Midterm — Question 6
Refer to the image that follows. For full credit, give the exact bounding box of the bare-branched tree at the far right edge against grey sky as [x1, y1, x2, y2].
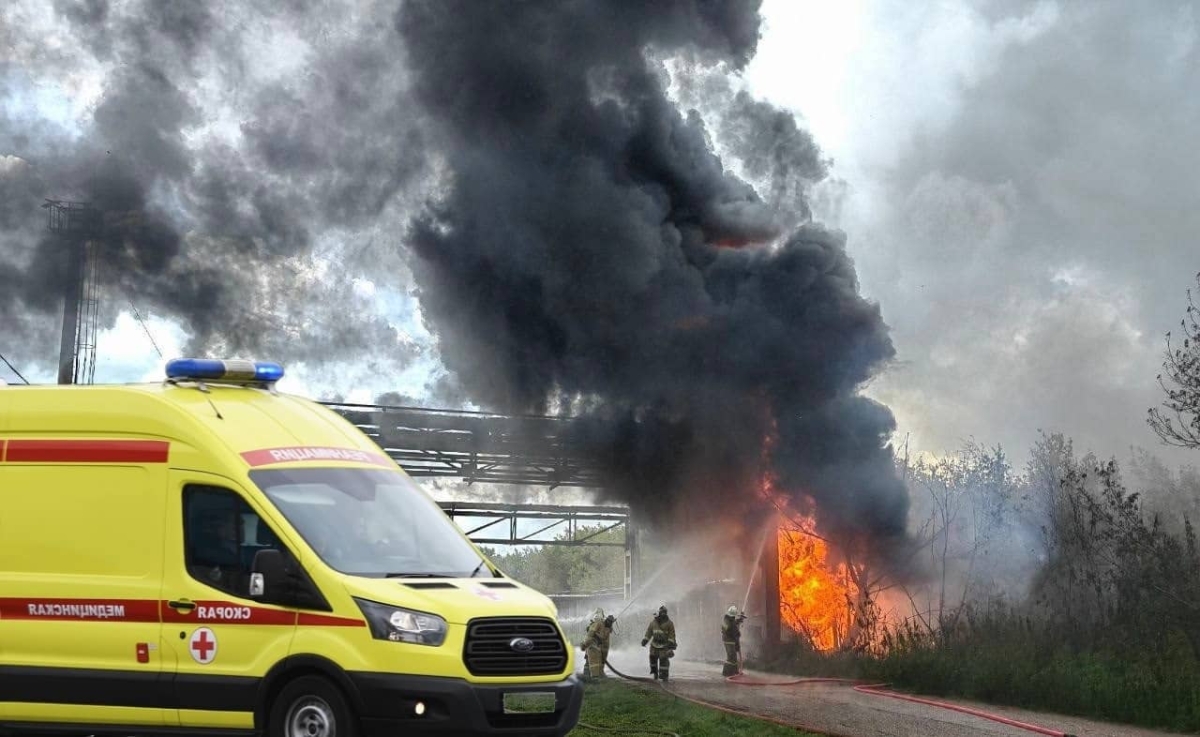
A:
[1146, 274, 1200, 448]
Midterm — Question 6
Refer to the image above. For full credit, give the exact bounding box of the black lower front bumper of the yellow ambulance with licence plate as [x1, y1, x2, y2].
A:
[349, 672, 583, 737]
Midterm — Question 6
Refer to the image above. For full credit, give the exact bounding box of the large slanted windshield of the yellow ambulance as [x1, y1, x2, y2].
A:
[250, 468, 493, 577]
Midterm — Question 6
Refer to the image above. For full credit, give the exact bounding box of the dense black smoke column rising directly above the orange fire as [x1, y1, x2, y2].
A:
[397, 0, 907, 554]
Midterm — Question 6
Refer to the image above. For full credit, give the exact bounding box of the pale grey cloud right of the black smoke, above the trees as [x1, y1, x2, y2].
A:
[840, 2, 1200, 465]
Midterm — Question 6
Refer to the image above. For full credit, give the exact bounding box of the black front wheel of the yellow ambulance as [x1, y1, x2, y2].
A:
[266, 676, 359, 737]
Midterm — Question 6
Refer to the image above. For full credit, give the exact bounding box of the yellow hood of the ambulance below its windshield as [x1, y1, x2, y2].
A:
[346, 577, 557, 624]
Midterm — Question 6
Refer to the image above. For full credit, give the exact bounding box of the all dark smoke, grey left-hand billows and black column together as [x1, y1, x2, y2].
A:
[0, 0, 906, 566]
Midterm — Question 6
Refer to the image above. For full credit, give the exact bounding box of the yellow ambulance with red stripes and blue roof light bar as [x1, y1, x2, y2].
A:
[0, 359, 582, 737]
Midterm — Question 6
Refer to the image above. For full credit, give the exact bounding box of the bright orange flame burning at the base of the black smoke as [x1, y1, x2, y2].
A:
[778, 517, 857, 651]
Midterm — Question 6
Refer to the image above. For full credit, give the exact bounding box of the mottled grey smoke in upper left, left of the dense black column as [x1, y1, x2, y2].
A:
[0, 0, 425, 369]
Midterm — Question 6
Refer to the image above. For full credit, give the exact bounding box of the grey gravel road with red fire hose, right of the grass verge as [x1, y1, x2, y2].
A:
[608, 651, 1174, 737]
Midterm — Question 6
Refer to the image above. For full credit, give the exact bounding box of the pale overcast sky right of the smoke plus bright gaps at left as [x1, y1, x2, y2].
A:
[0, 0, 1200, 472]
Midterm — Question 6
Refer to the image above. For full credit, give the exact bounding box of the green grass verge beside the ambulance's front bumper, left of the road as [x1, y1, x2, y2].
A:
[570, 678, 817, 737]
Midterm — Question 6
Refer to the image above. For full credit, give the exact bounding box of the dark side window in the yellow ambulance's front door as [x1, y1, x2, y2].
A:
[184, 484, 290, 599]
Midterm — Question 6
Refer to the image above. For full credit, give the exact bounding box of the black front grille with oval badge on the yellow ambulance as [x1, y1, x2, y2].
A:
[462, 617, 566, 676]
